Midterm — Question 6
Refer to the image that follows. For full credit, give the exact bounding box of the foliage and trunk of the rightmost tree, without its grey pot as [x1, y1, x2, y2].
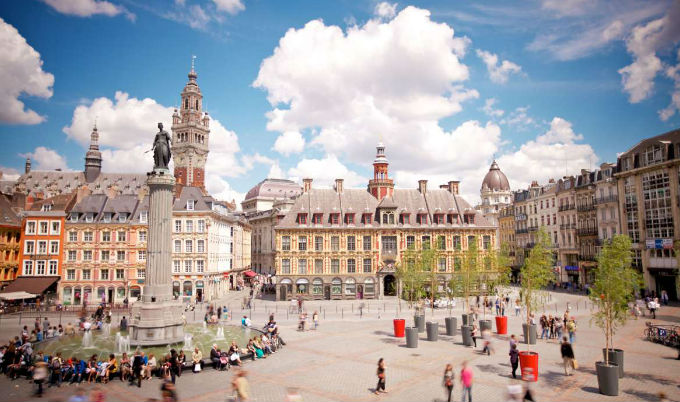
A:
[589, 235, 642, 364]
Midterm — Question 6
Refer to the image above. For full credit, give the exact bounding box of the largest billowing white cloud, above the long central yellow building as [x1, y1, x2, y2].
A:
[253, 7, 488, 189]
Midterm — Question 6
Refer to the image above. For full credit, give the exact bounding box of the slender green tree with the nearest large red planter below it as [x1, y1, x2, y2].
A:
[519, 227, 553, 381]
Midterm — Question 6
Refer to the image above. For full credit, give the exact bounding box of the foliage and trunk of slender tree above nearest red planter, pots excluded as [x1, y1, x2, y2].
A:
[520, 227, 554, 325]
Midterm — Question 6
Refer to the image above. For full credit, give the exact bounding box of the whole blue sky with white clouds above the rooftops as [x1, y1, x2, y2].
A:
[0, 0, 680, 202]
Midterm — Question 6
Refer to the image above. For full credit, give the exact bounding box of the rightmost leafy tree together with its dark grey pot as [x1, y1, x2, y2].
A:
[589, 235, 642, 395]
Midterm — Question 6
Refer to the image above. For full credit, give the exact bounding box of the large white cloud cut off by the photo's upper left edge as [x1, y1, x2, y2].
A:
[0, 18, 54, 124]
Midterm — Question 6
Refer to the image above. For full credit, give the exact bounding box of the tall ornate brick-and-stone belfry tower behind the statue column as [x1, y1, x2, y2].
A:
[171, 57, 210, 193]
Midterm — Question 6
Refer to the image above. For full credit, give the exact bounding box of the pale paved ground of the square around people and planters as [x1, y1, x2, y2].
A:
[0, 293, 680, 401]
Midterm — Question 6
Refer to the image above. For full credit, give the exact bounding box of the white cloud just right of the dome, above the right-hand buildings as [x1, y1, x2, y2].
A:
[498, 117, 598, 188]
